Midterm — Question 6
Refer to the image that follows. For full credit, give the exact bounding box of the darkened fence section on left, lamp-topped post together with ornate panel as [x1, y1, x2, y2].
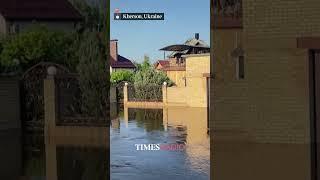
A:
[44, 66, 109, 127]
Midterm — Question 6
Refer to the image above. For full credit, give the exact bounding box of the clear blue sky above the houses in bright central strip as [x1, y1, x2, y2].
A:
[110, 0, 210, 62]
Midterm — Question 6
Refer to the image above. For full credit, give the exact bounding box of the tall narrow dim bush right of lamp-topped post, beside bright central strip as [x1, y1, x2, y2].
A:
[77, 32, 110, 118]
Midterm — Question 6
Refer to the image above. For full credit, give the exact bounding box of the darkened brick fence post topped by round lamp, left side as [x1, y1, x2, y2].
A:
[43, 66, 57, 136]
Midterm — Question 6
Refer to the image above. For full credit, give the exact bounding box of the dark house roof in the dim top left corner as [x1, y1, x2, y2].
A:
[0, 0, 82, 20]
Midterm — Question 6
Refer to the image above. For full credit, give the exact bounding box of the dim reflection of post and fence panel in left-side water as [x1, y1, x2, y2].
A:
[45, 126, 109, 180]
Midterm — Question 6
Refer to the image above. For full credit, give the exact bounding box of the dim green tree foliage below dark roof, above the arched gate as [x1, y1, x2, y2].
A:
[0, 0, 110, 73]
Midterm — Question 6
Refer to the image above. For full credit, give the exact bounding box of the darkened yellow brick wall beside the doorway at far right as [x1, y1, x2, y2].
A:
[243, 0, 320, 144]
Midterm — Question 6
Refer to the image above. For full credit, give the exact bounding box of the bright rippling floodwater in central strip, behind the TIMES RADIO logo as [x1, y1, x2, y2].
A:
[110, 107, 210, 180]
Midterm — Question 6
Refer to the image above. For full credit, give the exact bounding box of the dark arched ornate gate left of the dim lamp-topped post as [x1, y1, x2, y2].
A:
[20, 62, 69, 149]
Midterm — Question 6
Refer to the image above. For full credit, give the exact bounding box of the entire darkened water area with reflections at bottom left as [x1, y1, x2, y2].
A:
[0, 126, 109, 180]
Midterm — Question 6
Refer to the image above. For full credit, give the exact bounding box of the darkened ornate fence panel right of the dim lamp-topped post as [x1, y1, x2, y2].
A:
[55, 74, 108, 127]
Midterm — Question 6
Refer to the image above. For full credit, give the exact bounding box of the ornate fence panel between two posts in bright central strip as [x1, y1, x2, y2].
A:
[128, 84, 162, 102]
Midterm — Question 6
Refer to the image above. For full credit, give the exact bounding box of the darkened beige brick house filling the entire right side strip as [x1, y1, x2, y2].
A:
[210, 0, 320, 180]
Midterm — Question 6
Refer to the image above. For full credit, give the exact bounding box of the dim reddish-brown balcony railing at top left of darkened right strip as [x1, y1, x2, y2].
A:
[212, 0, 242, 28]
